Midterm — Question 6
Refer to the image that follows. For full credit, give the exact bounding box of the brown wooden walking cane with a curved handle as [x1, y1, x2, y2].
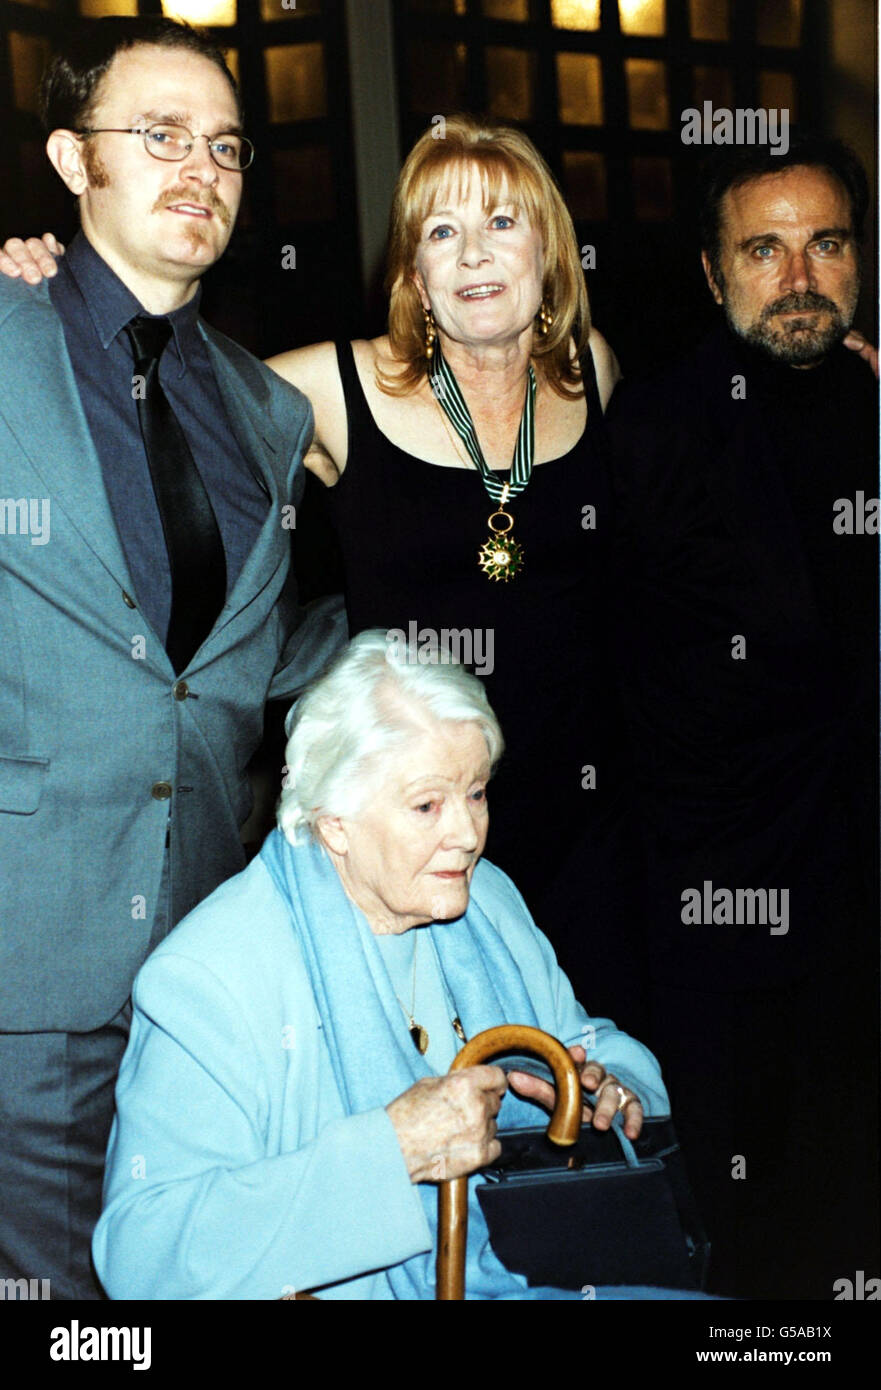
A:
[435, 1023, 582, 1300]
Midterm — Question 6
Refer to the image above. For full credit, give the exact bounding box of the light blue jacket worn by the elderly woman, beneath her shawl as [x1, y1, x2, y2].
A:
[93, 833, 668, 1300]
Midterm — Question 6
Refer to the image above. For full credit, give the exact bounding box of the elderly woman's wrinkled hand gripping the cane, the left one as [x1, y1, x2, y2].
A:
[385, 1066, 507, 1183]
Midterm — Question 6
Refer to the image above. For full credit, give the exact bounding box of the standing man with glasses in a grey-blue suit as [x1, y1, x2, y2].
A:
[0, 10, 345, 1298]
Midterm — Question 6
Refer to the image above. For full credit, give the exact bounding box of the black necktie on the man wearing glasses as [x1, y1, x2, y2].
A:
[125, 317, 227, 674]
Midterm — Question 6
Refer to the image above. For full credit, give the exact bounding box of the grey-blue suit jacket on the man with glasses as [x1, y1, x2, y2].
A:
[0, 279, 345, 1031]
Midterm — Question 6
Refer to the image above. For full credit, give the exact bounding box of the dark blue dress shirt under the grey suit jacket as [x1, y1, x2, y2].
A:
[49, 232, 270, 642]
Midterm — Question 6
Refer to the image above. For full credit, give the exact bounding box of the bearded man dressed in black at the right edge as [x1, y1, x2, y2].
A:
[609, 138, 878, 1300]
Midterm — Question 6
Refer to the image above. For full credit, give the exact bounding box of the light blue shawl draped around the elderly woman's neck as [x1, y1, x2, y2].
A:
[261, 831, 572, 1300]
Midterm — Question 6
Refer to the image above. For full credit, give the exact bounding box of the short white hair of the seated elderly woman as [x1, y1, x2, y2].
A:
[277, 628, 504, 844]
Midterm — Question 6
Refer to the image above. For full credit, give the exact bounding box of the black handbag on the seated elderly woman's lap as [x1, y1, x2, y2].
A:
[477, 1058, 710, 1295]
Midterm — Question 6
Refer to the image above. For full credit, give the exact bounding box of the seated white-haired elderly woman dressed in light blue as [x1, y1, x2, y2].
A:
[93, 632, 688, 1300]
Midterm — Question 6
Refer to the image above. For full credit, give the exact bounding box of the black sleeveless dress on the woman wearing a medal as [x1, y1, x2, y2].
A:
[328, 342, 641, 1026]
